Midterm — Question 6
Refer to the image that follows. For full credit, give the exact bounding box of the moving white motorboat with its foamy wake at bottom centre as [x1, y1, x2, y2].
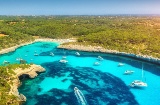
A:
[74, 87, 87, 105]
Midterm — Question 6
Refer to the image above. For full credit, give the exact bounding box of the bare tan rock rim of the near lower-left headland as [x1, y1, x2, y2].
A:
[9, 64, 45, 102]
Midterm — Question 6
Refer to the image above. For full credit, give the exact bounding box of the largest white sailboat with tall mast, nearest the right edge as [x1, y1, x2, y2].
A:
[130, 64, 147, 88]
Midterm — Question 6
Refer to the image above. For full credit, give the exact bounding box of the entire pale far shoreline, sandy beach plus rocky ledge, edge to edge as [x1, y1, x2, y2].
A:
[0, 38, 160, 64]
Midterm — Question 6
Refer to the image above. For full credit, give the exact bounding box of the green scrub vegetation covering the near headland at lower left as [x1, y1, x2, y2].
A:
[0, 64, 30, 105]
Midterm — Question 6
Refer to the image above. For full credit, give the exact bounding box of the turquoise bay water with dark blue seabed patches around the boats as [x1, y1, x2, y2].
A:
[0, 42, 160, 105]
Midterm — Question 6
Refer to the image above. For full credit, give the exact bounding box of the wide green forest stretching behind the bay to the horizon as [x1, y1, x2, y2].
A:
[0, 16, 160, 58]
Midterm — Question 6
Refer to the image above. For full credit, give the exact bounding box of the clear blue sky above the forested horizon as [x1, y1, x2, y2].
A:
[0, 0, 160, 15]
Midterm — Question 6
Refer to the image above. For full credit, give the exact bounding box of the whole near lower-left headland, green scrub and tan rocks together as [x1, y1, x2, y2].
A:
[0, 64, 45, 105]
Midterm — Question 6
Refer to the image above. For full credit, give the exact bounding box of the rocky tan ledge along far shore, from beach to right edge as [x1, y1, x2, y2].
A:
[58, 44, 160, 64]
